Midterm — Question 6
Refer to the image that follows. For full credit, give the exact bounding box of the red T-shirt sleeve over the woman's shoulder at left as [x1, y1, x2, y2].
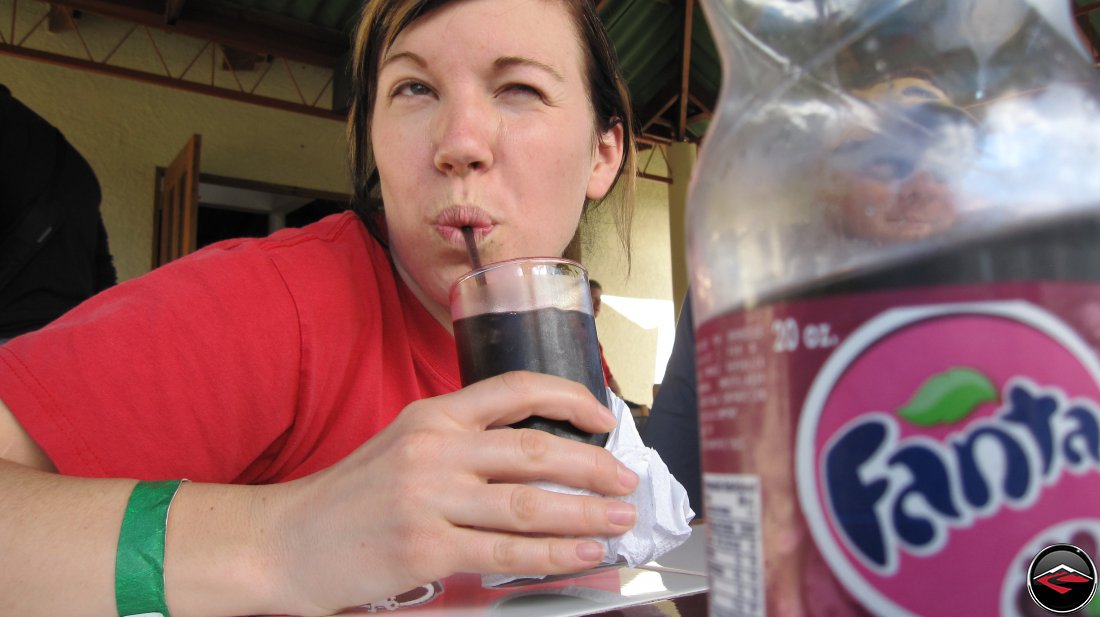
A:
[0, 243, 300, 482]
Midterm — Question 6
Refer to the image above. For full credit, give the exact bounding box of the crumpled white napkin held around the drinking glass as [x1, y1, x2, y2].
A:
[482, 389, 695, 587]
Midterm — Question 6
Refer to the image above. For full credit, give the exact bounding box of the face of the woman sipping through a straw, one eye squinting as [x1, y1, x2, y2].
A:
[371, 0, 623, 326]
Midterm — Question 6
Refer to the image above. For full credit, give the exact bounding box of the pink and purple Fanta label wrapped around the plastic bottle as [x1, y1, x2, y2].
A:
[696, 283, 1100, 617]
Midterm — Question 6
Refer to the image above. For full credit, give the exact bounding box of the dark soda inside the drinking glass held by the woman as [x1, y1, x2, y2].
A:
[454, 308, 608, 447]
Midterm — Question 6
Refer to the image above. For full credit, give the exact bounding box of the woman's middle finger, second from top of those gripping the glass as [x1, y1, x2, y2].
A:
[464, 429, 638, 495]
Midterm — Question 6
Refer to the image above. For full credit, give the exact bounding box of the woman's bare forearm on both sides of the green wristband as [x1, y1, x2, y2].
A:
[0, 461, 288, 617]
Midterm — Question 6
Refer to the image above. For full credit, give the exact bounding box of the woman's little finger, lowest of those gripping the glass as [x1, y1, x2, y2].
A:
[442, 521, 604, 575]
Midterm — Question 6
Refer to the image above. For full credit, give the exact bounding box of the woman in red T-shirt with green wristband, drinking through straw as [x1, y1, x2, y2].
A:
[0, 0, 637, 617]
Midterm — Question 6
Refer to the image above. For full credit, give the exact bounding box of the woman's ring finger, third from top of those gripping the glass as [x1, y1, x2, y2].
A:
[444, 484, 637, 537]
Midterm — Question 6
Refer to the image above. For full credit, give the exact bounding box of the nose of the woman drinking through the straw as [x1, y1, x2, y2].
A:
[432, 97, 501, 177]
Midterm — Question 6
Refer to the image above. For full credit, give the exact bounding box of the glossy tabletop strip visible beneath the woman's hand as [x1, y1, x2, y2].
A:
[341, 525, 707, 617]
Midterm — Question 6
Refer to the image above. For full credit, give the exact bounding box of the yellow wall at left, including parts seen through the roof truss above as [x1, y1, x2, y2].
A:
[0, 0, 350, 280]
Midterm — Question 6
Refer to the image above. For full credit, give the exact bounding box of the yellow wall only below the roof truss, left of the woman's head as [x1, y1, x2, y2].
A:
[0, 56, 350, 279]
